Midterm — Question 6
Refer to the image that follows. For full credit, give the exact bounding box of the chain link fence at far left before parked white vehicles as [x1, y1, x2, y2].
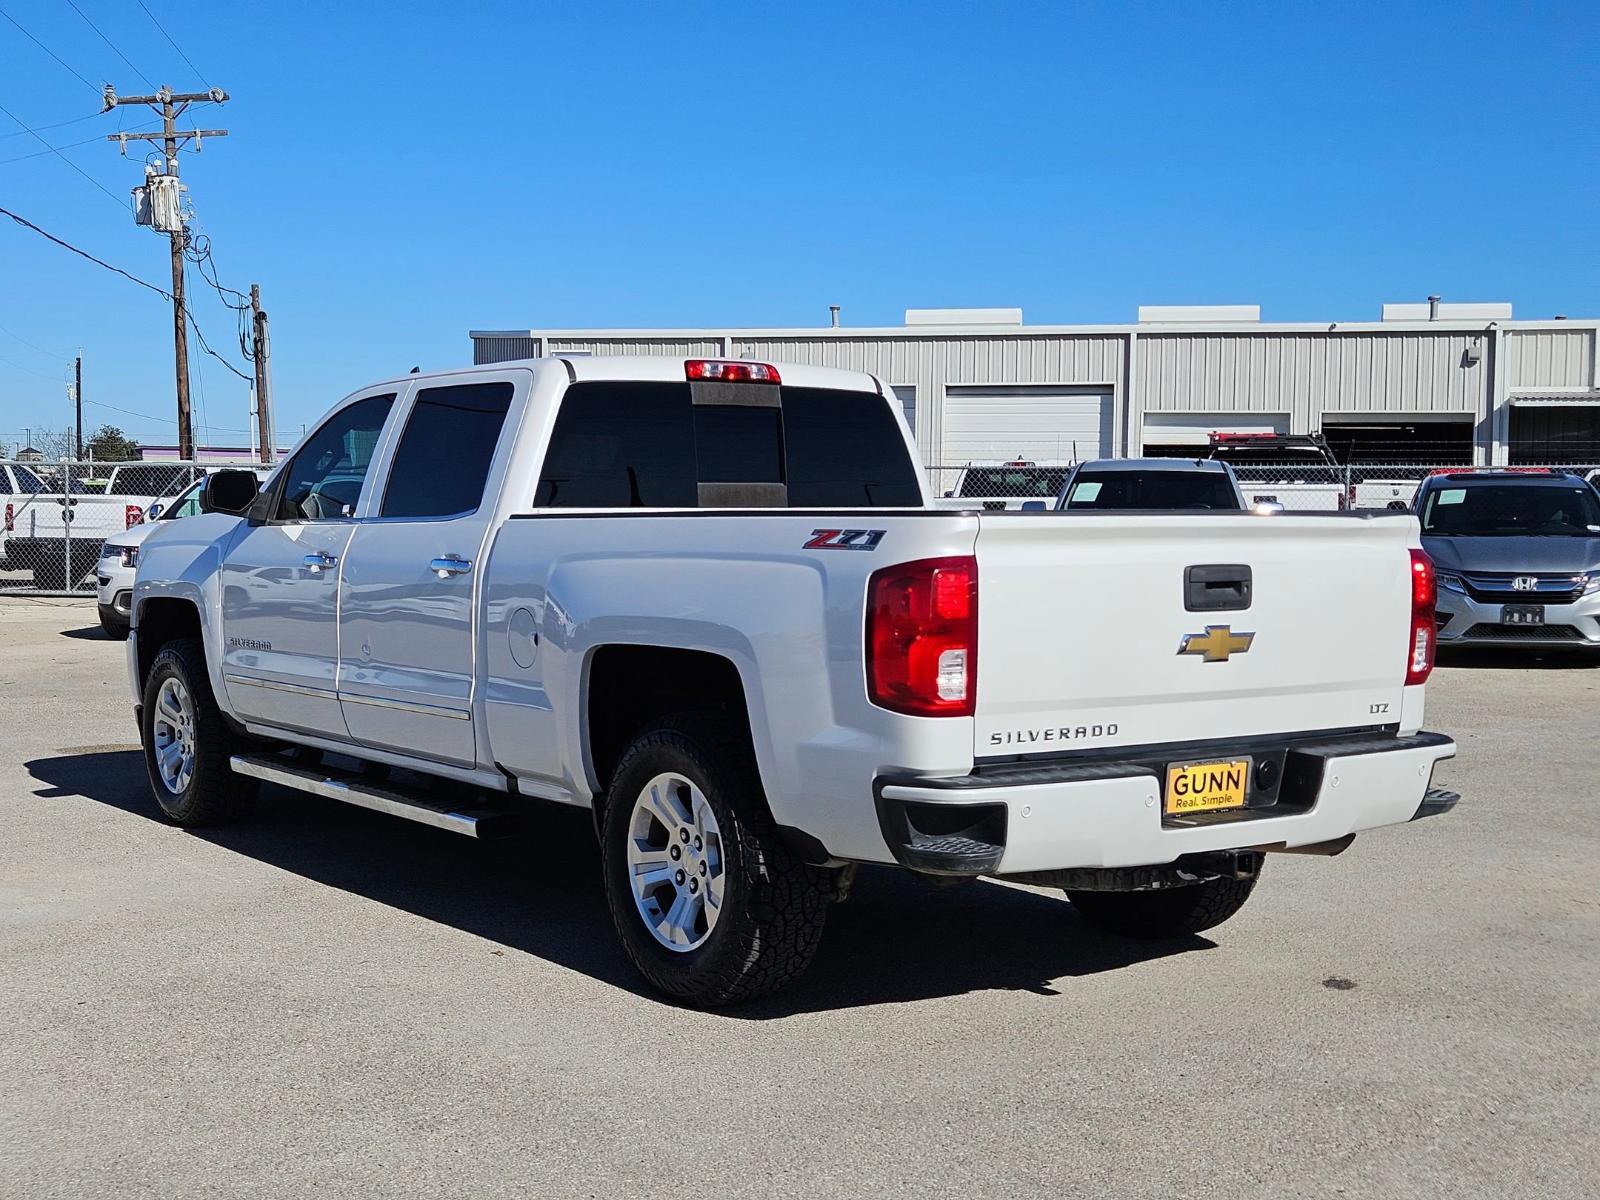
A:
[0, 459, 261, 595]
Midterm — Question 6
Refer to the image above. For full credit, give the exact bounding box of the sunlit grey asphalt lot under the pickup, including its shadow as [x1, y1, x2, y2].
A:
[0, 598, 1600, 1197]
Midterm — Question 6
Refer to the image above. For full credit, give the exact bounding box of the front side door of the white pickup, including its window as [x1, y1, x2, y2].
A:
[221, 390, 395, 738]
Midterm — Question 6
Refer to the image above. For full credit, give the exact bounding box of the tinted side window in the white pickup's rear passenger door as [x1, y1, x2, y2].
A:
[379, 382, 515, 517]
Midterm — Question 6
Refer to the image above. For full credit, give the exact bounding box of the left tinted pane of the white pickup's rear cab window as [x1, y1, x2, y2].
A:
[533, 382, 699, 509]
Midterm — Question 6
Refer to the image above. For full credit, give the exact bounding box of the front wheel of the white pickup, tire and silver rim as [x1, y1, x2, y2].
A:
[142, 637, 259, 829]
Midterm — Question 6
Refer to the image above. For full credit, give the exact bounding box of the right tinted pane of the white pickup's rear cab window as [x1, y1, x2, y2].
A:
[782, 384, 922, 509]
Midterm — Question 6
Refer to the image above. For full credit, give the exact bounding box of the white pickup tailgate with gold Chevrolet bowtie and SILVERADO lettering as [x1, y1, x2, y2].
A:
[974, 514, 1418, 758]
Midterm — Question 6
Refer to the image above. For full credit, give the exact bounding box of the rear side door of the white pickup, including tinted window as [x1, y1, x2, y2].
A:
[339, 371, 518, 766]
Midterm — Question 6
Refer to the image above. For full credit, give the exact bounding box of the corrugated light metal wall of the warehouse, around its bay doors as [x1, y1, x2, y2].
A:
[474, 322, 1600, 462]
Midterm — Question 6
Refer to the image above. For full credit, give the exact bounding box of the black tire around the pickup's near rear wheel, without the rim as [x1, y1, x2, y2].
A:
[600, 715, 830, 1008]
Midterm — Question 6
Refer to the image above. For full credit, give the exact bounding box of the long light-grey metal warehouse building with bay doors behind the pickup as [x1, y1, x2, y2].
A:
[472, 299, 1600, 466]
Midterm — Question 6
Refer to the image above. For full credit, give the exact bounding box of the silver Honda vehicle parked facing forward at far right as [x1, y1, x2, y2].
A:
[1416, 470, 1600, 650]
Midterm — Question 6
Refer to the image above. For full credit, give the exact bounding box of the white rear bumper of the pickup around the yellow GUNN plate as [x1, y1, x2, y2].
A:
[874, 733, 1456, 875]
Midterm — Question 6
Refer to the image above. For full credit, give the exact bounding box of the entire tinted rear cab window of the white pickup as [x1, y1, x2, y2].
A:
[533, 381, 923, 509]
